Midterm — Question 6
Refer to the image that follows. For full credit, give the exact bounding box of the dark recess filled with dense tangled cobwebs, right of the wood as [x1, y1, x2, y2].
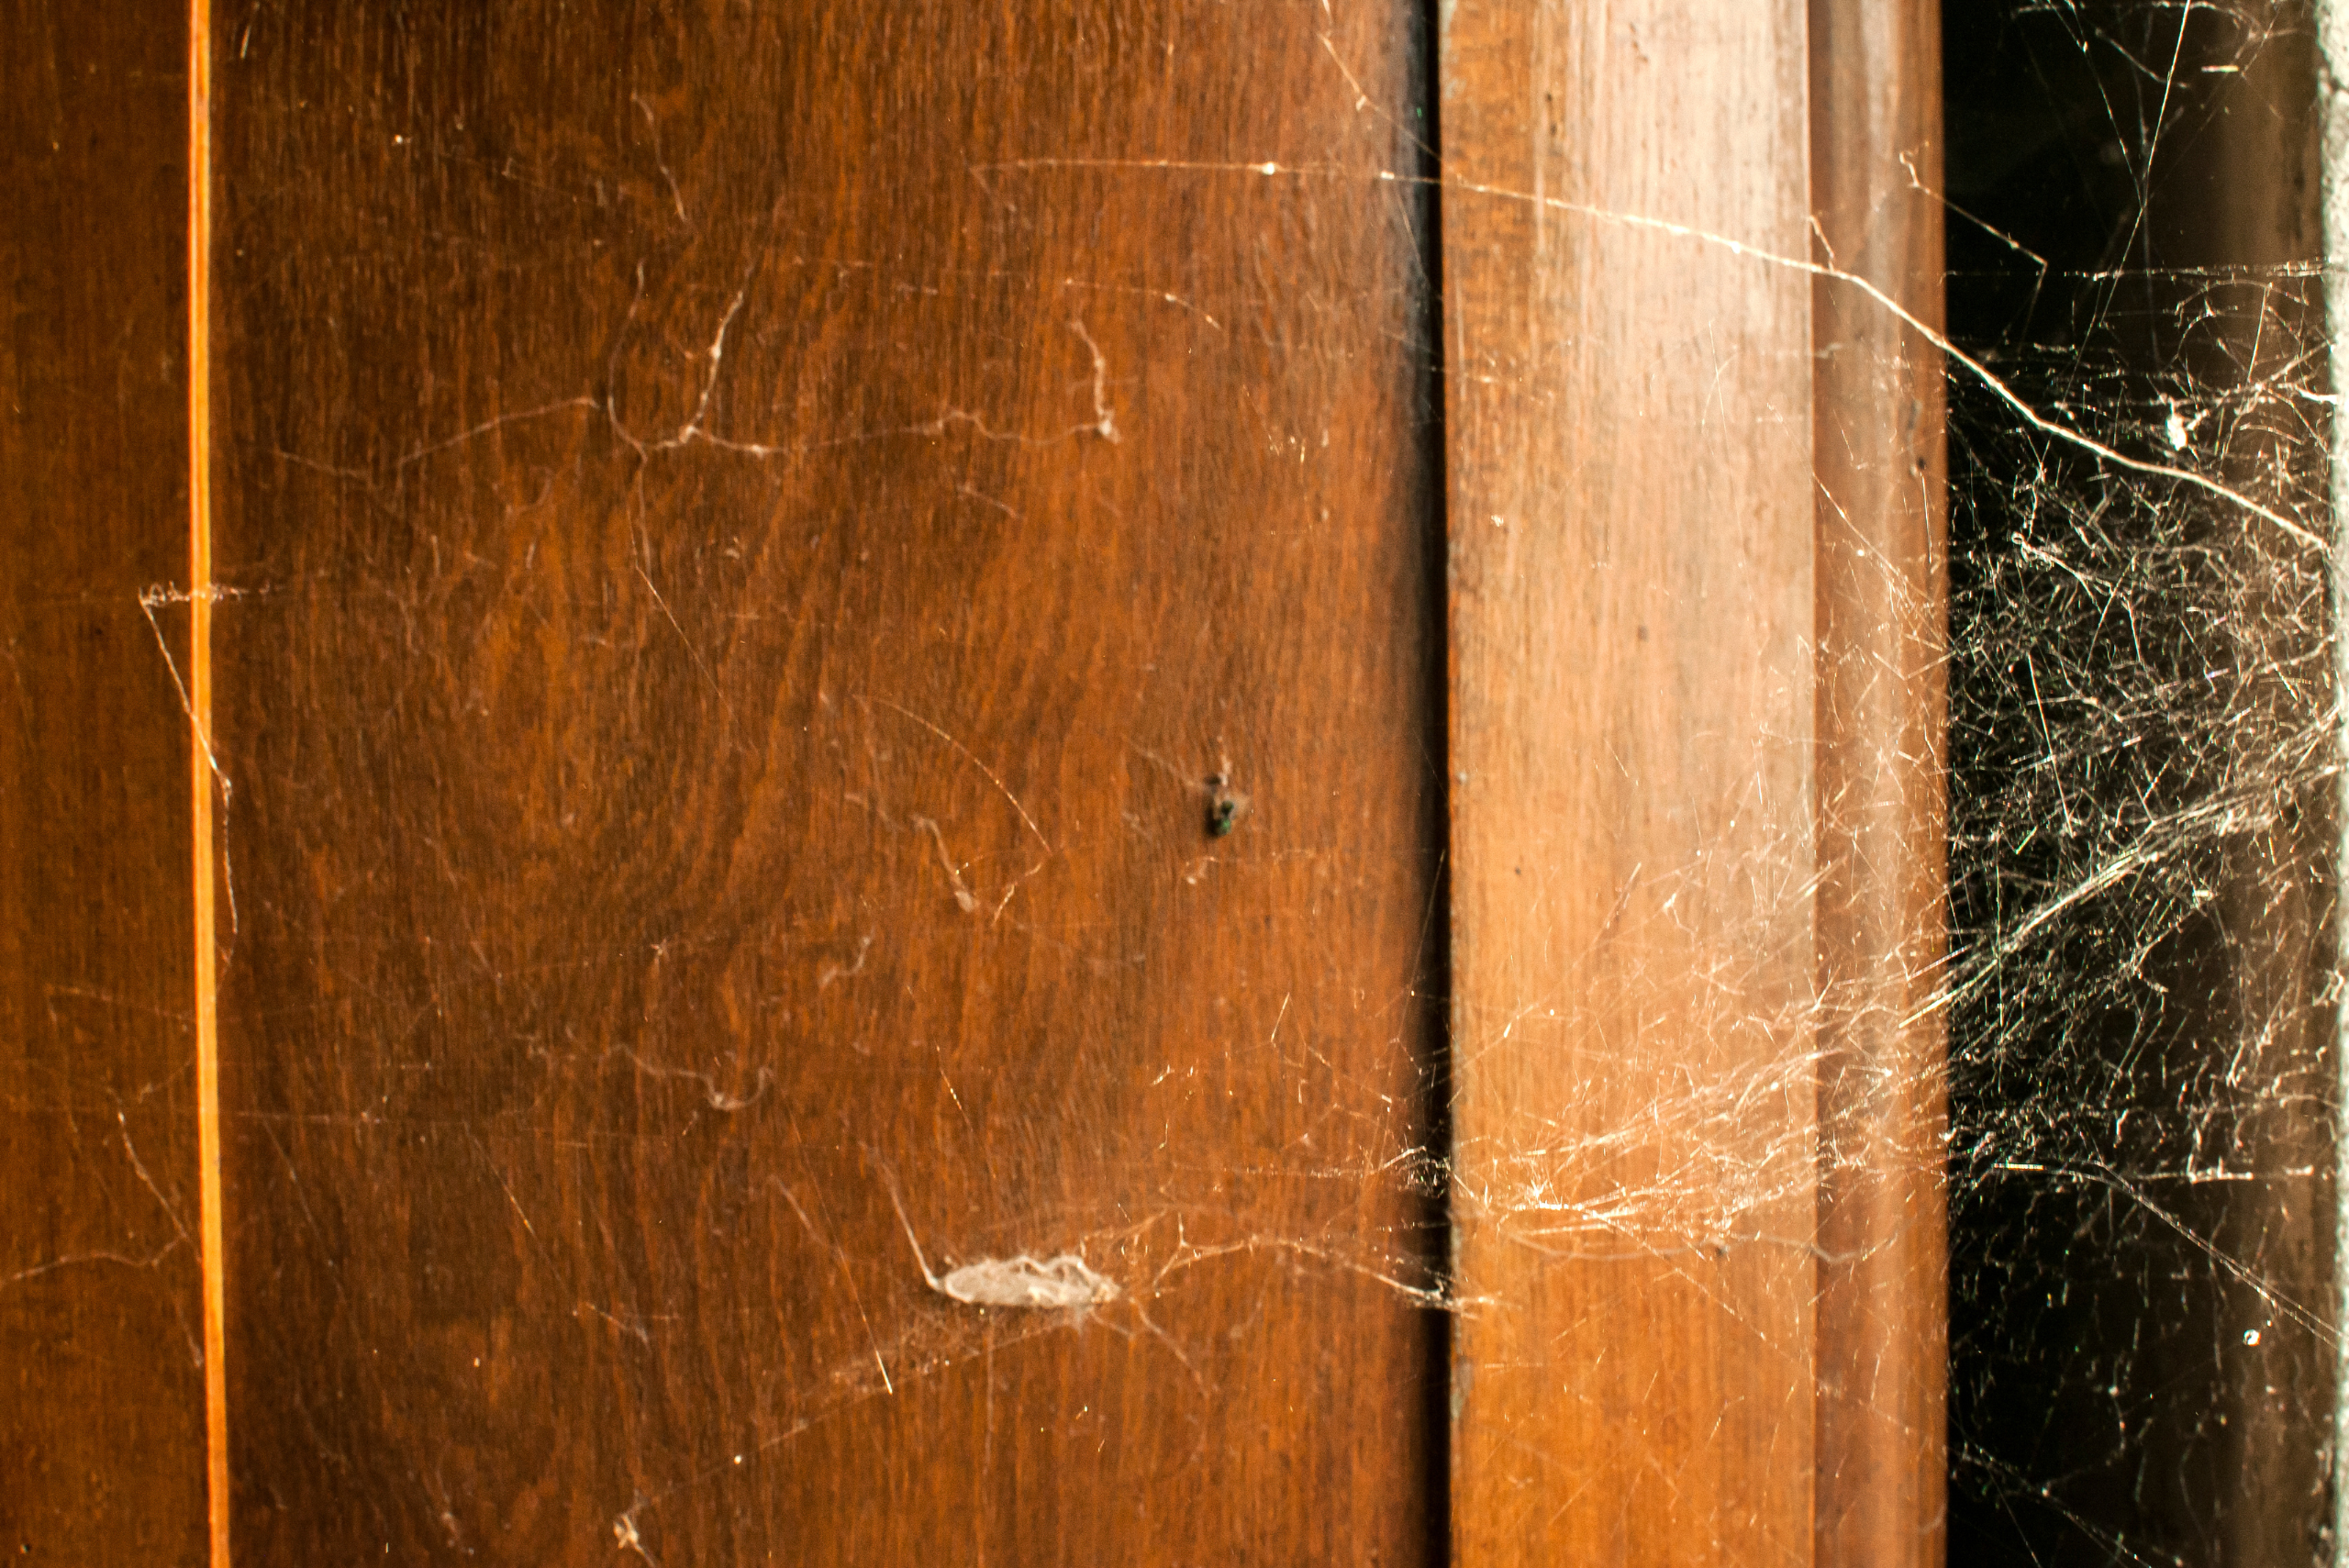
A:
[1945, 0, 2340, 1563]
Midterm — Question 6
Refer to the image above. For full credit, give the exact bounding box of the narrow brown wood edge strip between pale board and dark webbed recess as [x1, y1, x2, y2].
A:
[1811, 0, 1950, 1568]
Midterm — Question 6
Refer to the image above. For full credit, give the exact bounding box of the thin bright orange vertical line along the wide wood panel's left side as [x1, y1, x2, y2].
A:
[188, 0, 228, 1568]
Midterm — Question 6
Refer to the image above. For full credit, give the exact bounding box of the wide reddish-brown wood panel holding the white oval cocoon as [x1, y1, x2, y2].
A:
[214, 0, 1442, 1563]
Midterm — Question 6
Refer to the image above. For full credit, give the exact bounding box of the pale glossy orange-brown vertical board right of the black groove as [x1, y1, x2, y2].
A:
[1440, 0, 1818, 1568]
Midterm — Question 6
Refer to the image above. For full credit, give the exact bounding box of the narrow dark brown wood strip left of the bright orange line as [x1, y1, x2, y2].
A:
[0, 3, 205, 1563]
